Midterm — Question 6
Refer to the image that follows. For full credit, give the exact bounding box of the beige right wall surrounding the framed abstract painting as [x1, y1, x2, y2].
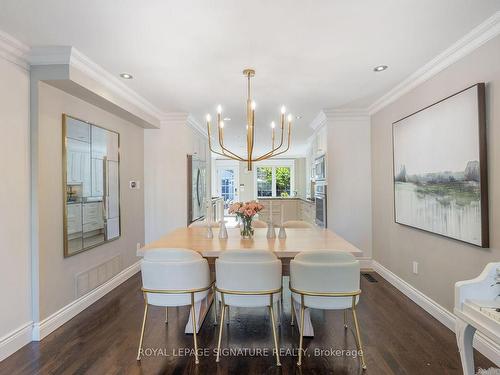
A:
[371, 37, 500, 310]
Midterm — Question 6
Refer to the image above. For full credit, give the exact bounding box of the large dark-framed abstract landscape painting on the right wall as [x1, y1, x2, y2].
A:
[392, 83, 489, 247]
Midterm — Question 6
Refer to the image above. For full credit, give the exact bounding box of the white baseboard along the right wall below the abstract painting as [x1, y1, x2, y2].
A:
[372, 260, 500, 366]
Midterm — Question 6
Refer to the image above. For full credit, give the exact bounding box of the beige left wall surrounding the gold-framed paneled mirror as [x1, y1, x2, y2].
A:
[38, 83, 144, 319]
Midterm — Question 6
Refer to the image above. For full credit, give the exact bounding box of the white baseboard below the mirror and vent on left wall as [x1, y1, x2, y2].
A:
[32, 261, 141, 341]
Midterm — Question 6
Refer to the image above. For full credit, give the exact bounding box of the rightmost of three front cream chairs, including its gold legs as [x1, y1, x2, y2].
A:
[290, 250, 366, 370]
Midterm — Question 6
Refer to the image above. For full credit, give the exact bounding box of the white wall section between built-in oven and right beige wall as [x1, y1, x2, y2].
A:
[327, 114, 372, 258]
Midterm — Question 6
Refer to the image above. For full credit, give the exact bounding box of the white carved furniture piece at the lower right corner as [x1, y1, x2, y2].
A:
[453, 262, 500, 375]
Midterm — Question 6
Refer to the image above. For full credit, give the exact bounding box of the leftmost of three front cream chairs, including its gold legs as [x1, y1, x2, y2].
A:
[137, 248, 213, 363]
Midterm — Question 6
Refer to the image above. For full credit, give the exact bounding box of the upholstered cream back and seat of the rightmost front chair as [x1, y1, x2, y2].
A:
[290, 250, 360, 310]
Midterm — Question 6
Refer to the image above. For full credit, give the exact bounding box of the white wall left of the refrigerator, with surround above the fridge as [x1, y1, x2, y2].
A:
[144, 116, 211, 243]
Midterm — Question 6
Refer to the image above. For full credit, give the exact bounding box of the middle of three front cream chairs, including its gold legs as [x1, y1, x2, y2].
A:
[215, 249, 282, 366]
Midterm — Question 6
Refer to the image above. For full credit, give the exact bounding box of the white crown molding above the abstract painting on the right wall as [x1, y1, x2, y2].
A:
[368, 11, 500, 115]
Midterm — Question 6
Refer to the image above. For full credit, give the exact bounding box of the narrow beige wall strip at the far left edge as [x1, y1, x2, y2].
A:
[0, 58, 31, 340]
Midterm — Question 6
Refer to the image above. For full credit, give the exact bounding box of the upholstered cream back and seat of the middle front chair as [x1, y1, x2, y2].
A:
[215, 250, 281, 307]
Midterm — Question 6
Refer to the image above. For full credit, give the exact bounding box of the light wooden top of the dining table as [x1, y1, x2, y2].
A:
[137, 227, 363, 258]
